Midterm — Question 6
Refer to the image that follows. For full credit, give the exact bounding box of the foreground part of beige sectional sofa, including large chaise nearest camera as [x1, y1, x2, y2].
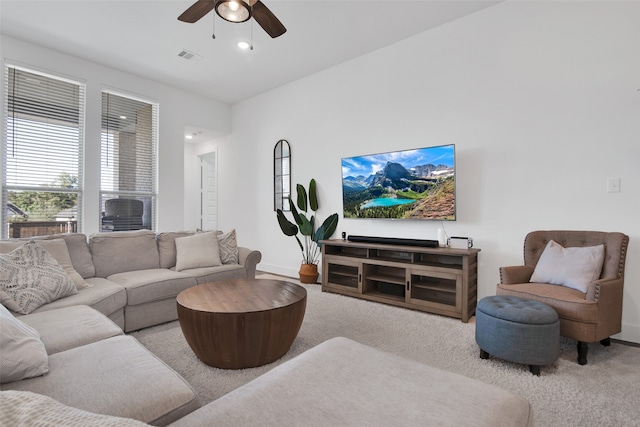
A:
[0, 306, 533, 427]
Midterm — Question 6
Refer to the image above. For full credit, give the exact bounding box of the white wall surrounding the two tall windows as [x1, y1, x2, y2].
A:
[0, 36, 231, 234]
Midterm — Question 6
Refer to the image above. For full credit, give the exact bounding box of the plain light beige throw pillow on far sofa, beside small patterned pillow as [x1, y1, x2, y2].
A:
[176, 231, 222, 271]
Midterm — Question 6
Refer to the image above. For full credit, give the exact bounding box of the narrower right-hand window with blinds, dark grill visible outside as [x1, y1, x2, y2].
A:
[100, 91, 158, 231]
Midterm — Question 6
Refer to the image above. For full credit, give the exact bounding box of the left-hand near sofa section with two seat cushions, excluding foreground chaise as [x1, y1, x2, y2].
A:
[0, 305, 200, 426]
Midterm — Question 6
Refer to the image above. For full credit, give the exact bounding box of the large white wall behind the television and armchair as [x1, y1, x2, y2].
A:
[218, 2, 640, 342]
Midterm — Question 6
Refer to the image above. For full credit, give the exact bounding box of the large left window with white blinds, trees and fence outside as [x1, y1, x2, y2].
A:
[0, 65, 85, 238]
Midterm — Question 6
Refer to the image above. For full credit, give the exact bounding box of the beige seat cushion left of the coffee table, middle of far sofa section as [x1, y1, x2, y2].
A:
[108, 268, 196, 306]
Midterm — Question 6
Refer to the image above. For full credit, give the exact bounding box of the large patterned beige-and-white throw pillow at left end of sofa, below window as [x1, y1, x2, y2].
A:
[0, 240, 78, 314]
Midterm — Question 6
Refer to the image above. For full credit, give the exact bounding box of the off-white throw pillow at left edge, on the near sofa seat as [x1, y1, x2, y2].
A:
[0, 304, 49, 384]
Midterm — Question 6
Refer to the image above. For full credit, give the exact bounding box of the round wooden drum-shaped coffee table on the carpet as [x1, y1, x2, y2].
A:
[177, 279, 307, 369]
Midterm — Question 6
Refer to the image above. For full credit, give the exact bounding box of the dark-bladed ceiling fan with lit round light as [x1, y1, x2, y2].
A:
[178, 0, 287, 38]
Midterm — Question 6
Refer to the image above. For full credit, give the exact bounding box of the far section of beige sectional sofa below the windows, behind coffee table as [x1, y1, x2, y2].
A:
[0, 230, 262, 332]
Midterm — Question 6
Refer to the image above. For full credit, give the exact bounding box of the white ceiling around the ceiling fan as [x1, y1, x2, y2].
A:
[0, 0, 502, 104]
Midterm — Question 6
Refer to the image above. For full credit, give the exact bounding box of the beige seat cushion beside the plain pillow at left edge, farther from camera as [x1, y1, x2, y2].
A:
[20, 305, 123, 355]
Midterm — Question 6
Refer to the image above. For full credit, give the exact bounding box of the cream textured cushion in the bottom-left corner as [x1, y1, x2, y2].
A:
[0, 390, 148, 427]
